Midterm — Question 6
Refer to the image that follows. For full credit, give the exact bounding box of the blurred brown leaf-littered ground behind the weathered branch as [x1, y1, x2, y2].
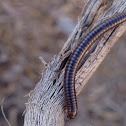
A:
[0, 0, 126, 126]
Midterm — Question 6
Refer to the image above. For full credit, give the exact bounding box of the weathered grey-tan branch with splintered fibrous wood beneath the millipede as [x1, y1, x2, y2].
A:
[24, 0, 126, 126]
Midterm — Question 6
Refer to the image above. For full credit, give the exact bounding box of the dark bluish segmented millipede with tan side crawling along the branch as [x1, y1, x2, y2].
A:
[64, 12, 126, 119]
